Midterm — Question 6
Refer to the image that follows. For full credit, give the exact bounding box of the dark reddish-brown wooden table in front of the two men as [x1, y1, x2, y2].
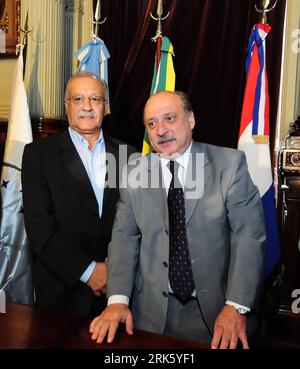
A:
[0, 303, 209, 350]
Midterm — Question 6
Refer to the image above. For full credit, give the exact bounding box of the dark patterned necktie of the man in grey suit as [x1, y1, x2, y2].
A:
[168, 160, 195, 303]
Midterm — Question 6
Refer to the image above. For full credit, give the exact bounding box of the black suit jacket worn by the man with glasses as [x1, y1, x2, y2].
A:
[22, 131, 134, 315]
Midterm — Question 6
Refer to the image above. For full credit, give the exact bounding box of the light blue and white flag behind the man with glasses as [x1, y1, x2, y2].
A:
[75, 37, 110, 114]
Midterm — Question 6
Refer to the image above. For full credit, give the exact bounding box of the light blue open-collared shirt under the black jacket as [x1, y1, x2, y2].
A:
[69, 127, 106, 283]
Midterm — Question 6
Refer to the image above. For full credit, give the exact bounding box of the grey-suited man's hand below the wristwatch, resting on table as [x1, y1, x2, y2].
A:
[211, 305, 249, 349]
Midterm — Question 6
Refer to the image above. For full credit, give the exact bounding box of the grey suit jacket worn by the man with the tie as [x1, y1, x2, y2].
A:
[108, 142, 265, 333]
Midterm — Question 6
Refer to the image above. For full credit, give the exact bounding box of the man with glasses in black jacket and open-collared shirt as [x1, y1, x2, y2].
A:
[22, 72, 133, 316]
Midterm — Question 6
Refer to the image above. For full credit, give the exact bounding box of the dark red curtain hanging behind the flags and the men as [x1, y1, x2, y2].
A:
[95, 0, 285, 149]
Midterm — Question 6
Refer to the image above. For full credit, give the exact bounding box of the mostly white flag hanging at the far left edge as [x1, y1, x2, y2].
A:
[0, 45, 34, 304]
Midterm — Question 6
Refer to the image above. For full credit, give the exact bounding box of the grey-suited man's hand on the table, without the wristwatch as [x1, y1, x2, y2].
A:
[90, 304, 133, 343]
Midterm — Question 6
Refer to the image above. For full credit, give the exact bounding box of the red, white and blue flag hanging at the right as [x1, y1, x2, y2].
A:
[238, 24, 280, 277]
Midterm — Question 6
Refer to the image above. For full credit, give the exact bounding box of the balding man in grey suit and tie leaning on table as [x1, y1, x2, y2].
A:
[90, 91, 265, 348]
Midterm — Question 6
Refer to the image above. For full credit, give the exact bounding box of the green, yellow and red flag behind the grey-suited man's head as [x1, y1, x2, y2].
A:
[142, 37, 176, 155]
